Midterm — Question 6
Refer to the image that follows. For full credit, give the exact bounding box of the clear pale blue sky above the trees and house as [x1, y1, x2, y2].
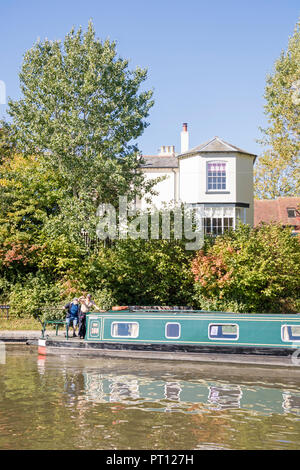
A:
[0, 0, 300, 155]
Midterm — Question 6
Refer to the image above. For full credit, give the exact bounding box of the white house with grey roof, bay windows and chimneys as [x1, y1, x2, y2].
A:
[136, 123, 256, 234]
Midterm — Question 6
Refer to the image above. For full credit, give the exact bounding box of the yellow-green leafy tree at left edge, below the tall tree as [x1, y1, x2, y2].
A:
[0, 154, 63, 284]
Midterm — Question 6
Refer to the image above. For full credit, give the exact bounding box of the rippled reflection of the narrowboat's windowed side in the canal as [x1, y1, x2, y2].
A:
[84, 372, 300, 414]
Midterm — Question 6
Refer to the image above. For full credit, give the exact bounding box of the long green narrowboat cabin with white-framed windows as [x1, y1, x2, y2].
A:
[85, 307, 300, 355]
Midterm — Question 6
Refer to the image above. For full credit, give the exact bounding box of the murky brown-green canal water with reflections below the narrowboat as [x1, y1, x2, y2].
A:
[0, 345, 300, 450]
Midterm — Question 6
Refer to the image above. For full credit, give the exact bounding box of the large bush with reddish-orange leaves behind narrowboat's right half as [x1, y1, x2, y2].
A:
[192, 224, 300, 313]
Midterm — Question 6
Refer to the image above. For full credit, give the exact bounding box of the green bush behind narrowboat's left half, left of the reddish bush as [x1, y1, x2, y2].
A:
[80, 239, 194, 305]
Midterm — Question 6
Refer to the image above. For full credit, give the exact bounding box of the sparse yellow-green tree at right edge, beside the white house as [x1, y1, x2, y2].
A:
[255, 22, 300, 199]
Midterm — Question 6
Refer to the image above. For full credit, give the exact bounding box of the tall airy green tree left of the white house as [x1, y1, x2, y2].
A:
[4, 22, 153, 207]
